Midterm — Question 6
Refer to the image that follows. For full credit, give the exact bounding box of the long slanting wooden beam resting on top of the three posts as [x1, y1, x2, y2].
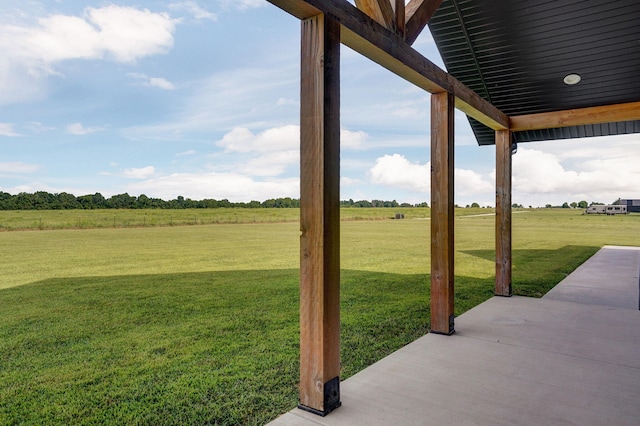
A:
[268, 0, 509, 130]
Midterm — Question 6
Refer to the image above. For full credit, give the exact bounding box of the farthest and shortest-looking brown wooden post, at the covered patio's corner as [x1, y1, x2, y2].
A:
[495, 130, 511, 297]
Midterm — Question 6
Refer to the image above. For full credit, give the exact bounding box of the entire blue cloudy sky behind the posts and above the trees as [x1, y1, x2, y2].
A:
[0, 0, 640, 206]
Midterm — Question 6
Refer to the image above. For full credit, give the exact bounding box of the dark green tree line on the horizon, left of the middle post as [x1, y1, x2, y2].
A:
[0, 191, 429, 210]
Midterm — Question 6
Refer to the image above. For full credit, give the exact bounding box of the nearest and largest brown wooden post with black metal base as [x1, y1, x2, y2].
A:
[299, 15, 341, 416]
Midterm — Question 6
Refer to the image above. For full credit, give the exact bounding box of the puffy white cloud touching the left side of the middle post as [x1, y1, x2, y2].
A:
[369, 154, 431, 193]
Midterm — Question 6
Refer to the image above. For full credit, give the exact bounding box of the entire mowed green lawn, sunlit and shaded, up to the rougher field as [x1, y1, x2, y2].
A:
[0, 209, 640, 425]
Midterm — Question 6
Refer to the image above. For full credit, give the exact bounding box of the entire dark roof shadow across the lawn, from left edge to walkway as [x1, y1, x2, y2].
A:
[0, 246, 597, 425]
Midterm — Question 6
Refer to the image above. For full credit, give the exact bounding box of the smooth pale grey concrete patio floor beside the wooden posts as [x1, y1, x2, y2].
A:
[272, 248, 640, 425]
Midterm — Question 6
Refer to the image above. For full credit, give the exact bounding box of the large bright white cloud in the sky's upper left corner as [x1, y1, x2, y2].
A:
[0, 5, 178, 104]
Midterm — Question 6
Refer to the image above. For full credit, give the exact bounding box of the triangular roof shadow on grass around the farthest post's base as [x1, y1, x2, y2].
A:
[463, 245, 600, 297]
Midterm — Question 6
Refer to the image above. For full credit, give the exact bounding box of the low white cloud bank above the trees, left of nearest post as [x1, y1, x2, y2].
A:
[127, 172, 300, 202]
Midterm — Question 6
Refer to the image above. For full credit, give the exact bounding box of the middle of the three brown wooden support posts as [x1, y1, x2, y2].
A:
[431, 92, 455, 334]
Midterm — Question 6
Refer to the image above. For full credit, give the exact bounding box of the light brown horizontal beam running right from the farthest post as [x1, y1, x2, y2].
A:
[511, 102, 640, 132]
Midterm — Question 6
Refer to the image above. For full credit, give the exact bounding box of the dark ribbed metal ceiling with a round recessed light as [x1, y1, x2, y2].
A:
[429, 0, 640, 145]
